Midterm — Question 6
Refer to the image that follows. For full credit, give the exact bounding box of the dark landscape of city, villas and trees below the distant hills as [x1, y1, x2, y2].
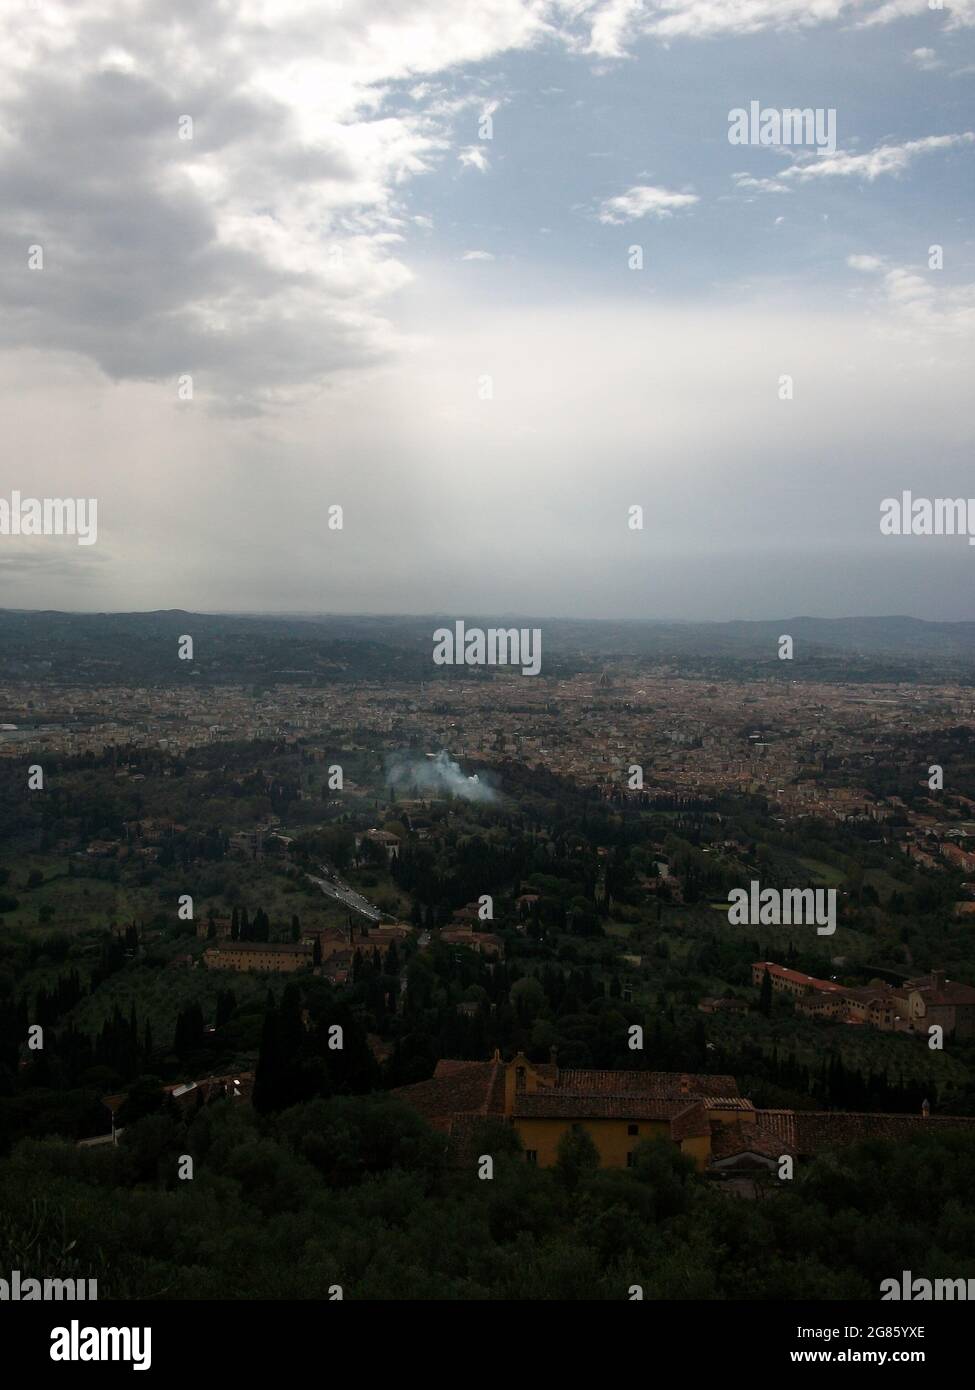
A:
[0, 616, 975, 1298]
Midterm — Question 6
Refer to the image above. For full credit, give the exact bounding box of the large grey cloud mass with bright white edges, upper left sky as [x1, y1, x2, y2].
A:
[0, 0, 549, 414]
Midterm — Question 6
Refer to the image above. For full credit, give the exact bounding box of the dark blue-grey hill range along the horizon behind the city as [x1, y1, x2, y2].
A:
[0, 609, 975, 685]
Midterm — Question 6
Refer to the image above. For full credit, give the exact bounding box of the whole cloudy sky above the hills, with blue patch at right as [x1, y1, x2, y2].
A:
[0, 0, 975, 620]
